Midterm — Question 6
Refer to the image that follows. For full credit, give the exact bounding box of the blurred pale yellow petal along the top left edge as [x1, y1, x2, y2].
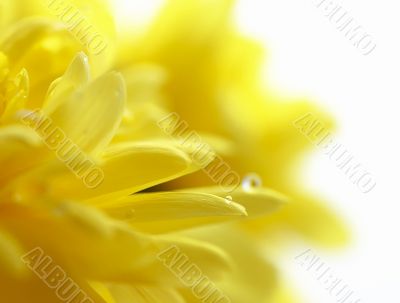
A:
[5, 0, 116, 76]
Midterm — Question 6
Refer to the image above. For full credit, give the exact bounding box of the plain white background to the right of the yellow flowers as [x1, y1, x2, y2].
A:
[116, 0, 400, 303]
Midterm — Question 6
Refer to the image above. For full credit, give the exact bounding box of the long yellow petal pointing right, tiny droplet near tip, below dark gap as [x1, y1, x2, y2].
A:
[100, 192, 246, 233]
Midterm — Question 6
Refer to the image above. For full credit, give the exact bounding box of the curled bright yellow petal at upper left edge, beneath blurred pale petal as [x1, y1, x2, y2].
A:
[0, 18, 82, 108]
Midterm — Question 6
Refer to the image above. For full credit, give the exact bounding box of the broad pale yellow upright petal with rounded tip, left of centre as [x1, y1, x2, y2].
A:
[45, 71, 125, 155]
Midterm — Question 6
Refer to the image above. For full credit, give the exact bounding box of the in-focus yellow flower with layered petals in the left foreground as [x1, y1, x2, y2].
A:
[0, 10, 279, 302]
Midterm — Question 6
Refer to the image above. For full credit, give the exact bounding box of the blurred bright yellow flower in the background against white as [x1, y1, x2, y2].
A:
[118, 0, 349, 302]
